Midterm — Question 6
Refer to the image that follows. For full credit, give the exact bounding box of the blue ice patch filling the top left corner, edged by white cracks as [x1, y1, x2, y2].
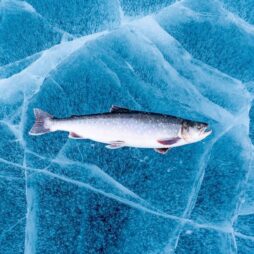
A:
[0, 0, 61, 65]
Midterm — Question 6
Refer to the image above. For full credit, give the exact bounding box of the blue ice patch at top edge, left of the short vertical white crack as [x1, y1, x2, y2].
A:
[27, 0, 120, 35]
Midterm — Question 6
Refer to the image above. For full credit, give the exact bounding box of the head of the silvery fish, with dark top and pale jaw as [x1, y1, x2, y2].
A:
[181, 120, 212, 143]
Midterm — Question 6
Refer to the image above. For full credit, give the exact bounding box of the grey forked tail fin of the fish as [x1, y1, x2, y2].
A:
[29, 108, 53, 135]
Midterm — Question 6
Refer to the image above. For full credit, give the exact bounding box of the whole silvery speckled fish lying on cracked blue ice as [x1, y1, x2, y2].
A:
[29, 105, 212, 154]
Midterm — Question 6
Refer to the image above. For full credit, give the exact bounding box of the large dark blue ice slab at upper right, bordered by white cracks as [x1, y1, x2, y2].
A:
[157, 0, 254, 82]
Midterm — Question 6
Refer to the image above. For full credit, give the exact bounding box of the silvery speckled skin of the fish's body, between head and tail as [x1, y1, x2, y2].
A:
[30, 107, 211, 152]
